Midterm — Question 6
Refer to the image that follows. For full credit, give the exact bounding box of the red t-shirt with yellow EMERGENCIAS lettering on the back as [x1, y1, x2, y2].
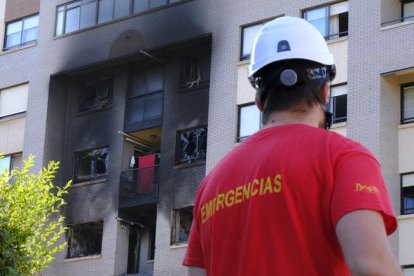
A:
[184, 125, 397, 276]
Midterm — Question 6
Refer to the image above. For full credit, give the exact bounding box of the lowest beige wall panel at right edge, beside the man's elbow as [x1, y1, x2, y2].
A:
[398, 215, 414, 266]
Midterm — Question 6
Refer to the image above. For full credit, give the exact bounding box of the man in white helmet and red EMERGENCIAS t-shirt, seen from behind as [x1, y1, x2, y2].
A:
[184, 17, 401, 276]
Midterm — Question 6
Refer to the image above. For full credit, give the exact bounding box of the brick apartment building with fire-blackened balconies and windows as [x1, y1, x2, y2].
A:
[0, 0, 414, 275]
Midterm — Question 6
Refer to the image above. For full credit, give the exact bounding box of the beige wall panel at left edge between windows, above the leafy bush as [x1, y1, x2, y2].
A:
[0, 117, 26, 154]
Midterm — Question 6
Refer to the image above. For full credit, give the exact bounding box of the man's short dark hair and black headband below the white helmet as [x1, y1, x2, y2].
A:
[255, 59, 329, 123]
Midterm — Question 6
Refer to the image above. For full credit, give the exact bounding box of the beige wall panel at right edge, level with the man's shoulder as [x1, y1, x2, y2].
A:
[398, 124, 414, 174]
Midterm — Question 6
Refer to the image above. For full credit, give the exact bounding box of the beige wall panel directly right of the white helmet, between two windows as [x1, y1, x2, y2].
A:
[328, 38, 348, 84]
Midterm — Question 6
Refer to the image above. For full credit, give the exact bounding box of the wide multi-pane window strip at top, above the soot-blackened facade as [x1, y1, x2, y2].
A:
[55, 0, 182, 36]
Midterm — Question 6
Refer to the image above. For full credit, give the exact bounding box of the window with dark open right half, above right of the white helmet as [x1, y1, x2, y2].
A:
[303, 1, 348, 39]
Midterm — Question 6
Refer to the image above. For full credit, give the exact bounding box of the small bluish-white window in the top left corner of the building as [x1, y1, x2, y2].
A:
[4, 15, 39, 50]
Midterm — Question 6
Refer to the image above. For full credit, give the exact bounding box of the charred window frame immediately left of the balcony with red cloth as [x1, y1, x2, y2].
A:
[73, 146, 110, 184]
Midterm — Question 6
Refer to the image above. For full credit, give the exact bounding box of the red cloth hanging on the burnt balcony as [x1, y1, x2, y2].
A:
[137, 154, 155, 194]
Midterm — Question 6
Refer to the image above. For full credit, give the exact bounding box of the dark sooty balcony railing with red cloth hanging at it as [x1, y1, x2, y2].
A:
[119, 166, 160, 208]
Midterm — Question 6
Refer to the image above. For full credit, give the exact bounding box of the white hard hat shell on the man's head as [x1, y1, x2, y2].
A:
[248, 16, 335, 81]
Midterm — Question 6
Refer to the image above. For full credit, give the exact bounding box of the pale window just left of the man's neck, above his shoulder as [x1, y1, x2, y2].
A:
[237, 103, 262, 142]
